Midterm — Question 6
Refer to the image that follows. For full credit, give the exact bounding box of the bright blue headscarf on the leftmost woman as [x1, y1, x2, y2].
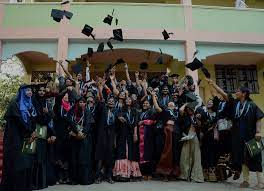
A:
[17, 86, 36, 123]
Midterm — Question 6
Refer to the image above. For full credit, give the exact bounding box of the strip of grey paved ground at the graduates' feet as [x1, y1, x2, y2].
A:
[45, 174, 256, 191]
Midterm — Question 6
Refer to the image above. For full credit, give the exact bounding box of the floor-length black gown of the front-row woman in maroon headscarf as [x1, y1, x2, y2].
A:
[70, 109, 93, 185]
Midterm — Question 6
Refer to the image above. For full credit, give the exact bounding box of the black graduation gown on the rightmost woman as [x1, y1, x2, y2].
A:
[231, 100, 264, 172]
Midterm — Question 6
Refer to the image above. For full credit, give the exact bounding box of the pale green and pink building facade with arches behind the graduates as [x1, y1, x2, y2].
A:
[0, 0, 264, 109]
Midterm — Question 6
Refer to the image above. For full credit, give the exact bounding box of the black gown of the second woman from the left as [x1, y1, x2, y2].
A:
[32, 97, 53, 189]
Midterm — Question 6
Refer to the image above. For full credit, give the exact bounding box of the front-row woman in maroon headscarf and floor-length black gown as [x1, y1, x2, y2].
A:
[70, 97, 93, 185]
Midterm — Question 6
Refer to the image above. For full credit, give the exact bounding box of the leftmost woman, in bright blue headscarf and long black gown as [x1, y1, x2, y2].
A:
[2, 85, 37, 191]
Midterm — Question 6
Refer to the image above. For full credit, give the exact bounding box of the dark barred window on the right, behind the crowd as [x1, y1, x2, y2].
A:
[215, 65, 259, 93]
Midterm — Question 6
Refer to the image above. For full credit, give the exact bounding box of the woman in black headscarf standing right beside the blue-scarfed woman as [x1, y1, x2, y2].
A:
[32, 84, 56, 189]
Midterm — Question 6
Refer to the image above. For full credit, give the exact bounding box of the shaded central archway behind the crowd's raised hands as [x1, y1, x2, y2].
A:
[76, 49, 173, 80]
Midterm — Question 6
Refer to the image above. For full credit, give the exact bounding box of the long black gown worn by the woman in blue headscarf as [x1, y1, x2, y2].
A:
[1, 100, 35, 191]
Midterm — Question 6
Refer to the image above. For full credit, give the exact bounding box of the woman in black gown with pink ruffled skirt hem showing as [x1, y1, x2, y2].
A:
[113, 97, 142, 182]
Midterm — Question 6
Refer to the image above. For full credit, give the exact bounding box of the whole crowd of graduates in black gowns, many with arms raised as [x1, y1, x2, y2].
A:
[1, 61, 264, 191]
